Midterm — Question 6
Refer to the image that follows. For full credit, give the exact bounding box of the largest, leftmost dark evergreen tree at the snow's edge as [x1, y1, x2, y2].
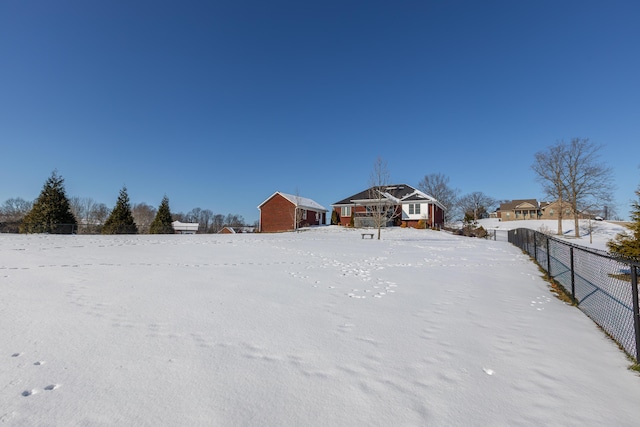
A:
[20, 171, 78, 234]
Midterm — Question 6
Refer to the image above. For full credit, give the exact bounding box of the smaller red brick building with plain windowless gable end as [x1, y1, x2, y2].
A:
[258, 191, 327, 233]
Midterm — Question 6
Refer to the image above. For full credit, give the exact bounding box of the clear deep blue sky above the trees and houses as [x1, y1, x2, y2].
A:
[0, 0, 640, 222]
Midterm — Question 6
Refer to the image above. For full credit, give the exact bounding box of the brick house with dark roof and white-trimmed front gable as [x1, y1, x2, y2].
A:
[331, 184, 445, 228]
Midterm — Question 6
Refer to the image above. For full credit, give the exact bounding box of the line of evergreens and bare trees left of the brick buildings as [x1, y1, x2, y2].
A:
[0, 171, 246, 234]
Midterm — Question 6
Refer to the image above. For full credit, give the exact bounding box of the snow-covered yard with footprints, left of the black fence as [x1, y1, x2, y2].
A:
[0, 227, 640, 426]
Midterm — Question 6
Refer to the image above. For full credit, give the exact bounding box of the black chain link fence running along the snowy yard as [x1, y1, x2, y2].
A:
[508, 228, 640, 361]
